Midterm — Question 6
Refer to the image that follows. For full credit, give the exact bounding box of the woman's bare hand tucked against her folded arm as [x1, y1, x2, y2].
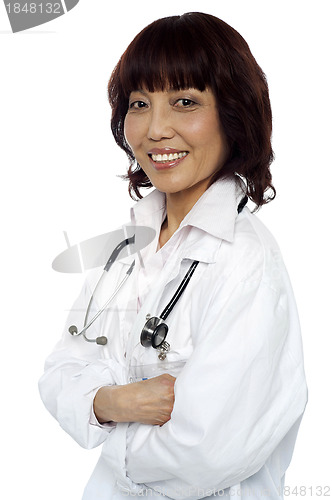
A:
[93, 373, 176, 425]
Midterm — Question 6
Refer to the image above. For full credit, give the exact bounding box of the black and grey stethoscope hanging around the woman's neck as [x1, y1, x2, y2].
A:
[68, 196, 248, 360]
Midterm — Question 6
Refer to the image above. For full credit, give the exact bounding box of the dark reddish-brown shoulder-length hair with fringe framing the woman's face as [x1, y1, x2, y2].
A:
[108, 12, 276, 208]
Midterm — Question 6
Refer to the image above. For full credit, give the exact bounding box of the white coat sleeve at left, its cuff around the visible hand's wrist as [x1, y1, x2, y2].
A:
[39, 276, 122, 449]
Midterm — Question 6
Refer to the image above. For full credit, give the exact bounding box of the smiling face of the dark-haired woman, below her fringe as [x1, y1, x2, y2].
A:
[124, 89, 228, 198]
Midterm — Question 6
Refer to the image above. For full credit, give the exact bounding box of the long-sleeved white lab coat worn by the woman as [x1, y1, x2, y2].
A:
[40, 174, 307, 500]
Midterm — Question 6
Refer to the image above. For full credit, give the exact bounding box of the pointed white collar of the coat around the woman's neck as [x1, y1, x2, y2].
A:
[131, 176, 245, 242]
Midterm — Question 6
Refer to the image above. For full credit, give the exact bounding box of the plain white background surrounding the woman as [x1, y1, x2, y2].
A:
[0, 0, 332, 500]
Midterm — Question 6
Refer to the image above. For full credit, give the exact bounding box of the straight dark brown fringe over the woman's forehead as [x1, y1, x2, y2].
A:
[120, 16, 211, 97]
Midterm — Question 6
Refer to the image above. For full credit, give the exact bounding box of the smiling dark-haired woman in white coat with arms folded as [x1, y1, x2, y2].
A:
[40, 13, 307, 500]
